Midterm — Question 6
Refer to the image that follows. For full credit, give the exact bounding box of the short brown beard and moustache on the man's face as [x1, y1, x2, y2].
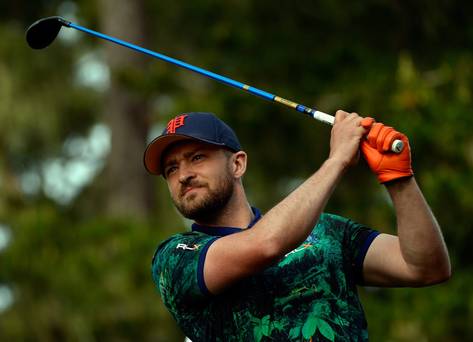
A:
[172, 170, 235, 222]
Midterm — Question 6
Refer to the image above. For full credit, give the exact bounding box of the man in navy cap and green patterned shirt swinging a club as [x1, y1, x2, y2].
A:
[145, 111, 450, 342]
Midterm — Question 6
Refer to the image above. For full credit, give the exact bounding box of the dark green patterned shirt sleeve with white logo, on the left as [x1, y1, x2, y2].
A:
[151, 233, 217, 312]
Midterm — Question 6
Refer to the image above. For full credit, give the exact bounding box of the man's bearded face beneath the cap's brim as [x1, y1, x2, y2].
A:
[163, 141, 235, 222]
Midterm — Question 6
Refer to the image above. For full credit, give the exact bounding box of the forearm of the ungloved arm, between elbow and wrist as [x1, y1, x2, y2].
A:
[254, 159, 346, 256]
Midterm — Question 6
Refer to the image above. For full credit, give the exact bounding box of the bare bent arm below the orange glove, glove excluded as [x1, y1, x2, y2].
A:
[363, 177, 451, 286]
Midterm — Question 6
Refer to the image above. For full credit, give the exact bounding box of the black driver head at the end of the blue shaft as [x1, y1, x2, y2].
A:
[26, 16, 70, 49]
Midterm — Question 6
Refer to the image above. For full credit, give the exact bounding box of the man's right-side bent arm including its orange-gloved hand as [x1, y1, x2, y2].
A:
[361, 123, 451, 286]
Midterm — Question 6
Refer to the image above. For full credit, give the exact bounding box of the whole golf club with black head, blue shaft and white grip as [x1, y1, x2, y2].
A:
[26, 16, 404, 153]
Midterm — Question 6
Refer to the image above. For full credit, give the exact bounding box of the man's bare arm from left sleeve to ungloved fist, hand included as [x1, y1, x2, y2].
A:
[204, 111, 366, 293]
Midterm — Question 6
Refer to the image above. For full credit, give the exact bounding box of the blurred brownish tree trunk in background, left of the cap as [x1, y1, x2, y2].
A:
[99, 0, 153, 218]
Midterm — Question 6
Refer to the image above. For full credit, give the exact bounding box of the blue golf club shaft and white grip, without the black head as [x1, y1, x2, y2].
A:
[63, 21, 404, 153]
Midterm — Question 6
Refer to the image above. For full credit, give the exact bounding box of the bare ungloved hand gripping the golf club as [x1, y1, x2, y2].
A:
[329, 110, 369, 168]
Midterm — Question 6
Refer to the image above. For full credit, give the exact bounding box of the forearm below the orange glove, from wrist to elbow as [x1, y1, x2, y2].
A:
[386, 177, 450, 282]
